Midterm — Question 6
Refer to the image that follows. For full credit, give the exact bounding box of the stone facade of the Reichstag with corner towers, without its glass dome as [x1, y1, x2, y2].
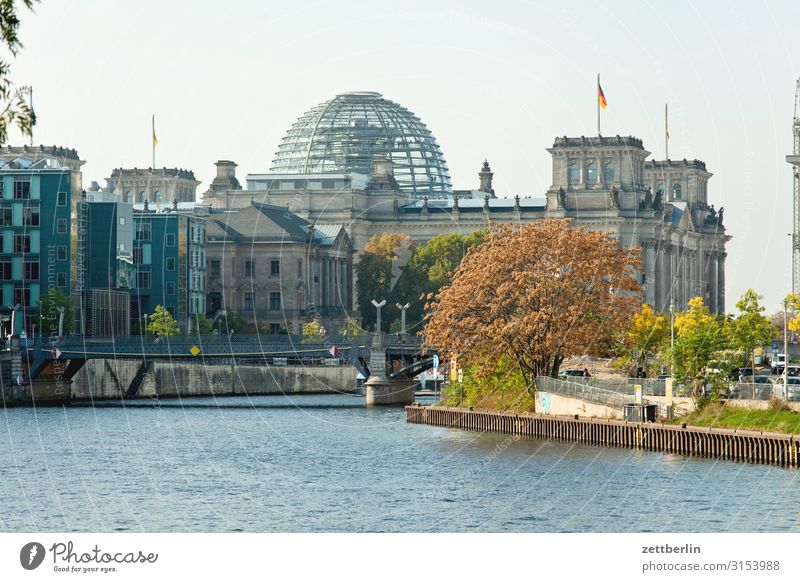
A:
[204, 136, 730, 313]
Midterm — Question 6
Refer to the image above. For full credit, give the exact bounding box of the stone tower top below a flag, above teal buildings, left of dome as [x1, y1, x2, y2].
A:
[108, 168, 200, 206]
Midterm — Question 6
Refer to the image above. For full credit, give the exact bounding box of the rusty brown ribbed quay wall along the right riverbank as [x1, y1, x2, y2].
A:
[406, 405, 800, 467]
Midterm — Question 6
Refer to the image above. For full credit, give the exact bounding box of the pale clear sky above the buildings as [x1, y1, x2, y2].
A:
[9, 0, 800, 311]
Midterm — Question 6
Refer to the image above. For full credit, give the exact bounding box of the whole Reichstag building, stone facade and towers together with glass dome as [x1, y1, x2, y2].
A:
[203, 92, 730, 313]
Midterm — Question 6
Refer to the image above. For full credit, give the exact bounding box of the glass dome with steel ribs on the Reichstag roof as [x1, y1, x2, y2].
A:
[270, 92, 452, 198]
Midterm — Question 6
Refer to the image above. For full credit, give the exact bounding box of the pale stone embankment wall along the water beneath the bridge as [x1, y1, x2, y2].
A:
[71, 360, 356, 400]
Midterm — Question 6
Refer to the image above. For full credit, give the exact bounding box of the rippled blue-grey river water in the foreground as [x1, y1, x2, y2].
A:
[0, 395, 800, 532]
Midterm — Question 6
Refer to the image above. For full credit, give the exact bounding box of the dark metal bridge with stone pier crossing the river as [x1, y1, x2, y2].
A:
[0, 334, 436, 405]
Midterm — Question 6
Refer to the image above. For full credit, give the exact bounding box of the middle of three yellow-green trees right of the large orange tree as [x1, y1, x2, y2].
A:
[669, 297, 728, 394]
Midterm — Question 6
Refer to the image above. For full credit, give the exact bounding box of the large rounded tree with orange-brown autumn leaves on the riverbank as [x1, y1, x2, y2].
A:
[425, 219, 641, 395]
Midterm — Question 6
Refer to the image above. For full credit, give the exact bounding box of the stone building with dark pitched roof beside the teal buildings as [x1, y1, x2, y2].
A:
[207, 201, 353, 333]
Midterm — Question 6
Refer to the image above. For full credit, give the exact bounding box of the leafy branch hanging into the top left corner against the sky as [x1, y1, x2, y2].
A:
[0, 0, 38, 143]
